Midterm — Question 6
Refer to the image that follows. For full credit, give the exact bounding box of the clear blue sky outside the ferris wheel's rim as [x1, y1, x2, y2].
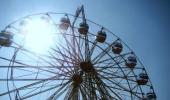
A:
[0, 0, 170, 100]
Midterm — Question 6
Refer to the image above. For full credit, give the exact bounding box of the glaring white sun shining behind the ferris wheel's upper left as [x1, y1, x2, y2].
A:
[22, 18, 56, 53]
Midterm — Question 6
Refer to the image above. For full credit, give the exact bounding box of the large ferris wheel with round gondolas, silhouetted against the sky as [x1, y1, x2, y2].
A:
[0, 6, 156, 100]
